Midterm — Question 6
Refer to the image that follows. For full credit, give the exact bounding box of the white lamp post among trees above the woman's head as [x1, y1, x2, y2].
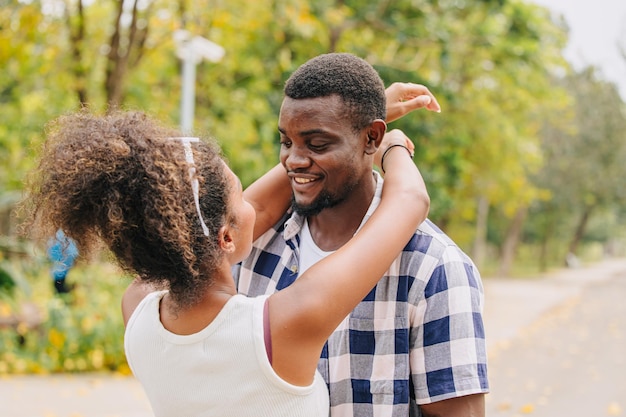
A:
[174, 30, 225, 134]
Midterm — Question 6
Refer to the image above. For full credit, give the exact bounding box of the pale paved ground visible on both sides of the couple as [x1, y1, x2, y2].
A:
[0, 260, 626, 417]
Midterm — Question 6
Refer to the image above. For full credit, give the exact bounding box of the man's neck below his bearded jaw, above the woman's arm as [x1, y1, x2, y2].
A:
[307, 171, 376, 251]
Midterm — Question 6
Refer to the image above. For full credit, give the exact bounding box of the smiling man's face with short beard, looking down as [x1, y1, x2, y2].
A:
[278, 96, 372, 216]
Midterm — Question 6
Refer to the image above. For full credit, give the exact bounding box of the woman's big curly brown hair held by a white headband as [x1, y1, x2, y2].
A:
[25, 111, 232, 307]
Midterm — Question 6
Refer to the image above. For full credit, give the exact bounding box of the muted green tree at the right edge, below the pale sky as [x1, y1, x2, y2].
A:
[535, 67, 626, 266]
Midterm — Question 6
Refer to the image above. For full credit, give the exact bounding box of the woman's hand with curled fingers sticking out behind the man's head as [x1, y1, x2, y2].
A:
[385, 83, 441, 123]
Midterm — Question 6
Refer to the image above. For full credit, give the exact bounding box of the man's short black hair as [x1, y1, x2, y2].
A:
[284, 53, 386, 131]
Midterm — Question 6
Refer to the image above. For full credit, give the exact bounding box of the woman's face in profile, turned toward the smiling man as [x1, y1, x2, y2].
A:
[226, 167, 256, 264]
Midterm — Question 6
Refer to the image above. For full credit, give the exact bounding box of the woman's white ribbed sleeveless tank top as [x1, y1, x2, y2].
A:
[124, 291, 329, 417]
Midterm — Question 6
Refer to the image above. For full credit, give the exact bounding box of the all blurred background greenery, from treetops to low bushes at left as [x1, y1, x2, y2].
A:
[0, 0, 626, 375]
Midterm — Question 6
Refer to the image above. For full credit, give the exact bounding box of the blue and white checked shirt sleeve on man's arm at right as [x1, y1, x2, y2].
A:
[410, 245, 488, 404]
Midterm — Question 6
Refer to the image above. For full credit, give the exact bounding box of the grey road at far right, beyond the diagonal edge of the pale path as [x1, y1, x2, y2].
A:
[487, 258, 626, 417]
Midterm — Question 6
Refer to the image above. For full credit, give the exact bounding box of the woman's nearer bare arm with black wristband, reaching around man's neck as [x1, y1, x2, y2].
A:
[269, 130, 430, 384]
